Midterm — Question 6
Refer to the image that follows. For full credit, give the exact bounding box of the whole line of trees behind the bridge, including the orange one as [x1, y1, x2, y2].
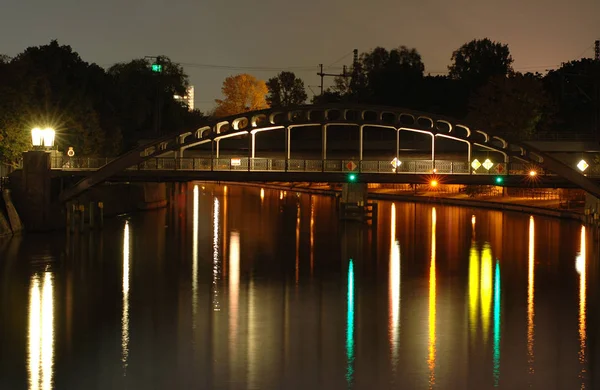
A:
[0, 38, 600, 163]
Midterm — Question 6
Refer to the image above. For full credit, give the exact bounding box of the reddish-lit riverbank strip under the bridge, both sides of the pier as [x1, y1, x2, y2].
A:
[216, 182, 586, 222]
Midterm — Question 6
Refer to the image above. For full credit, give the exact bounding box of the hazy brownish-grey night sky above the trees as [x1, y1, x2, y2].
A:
[0, 0, 600, 111]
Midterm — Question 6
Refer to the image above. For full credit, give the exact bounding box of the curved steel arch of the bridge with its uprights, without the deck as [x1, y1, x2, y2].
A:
[60, 104, 600, 201]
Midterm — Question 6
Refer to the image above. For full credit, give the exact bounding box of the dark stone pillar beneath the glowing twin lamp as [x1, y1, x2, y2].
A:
[18, 151, 52, 231]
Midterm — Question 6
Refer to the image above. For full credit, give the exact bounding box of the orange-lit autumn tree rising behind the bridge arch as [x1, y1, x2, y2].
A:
[215, 73, 269, 117]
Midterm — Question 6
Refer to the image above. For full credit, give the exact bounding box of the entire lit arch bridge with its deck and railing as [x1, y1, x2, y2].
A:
[60, 104, 600, 201]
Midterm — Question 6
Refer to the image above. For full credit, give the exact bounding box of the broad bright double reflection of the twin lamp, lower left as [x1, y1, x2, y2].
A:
[28, 271, 54, 390]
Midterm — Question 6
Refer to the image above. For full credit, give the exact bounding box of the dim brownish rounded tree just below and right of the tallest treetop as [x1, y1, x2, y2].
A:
[467, 73, 553, 139]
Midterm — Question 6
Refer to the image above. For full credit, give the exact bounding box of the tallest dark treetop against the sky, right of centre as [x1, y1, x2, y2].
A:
[448, 38, 513, 89]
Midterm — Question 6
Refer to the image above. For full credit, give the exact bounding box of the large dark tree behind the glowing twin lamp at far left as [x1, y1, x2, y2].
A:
[2, 41, 106, 155]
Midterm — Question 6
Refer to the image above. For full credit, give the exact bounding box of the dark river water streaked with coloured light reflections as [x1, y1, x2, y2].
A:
[0, 184, 599, 389]
